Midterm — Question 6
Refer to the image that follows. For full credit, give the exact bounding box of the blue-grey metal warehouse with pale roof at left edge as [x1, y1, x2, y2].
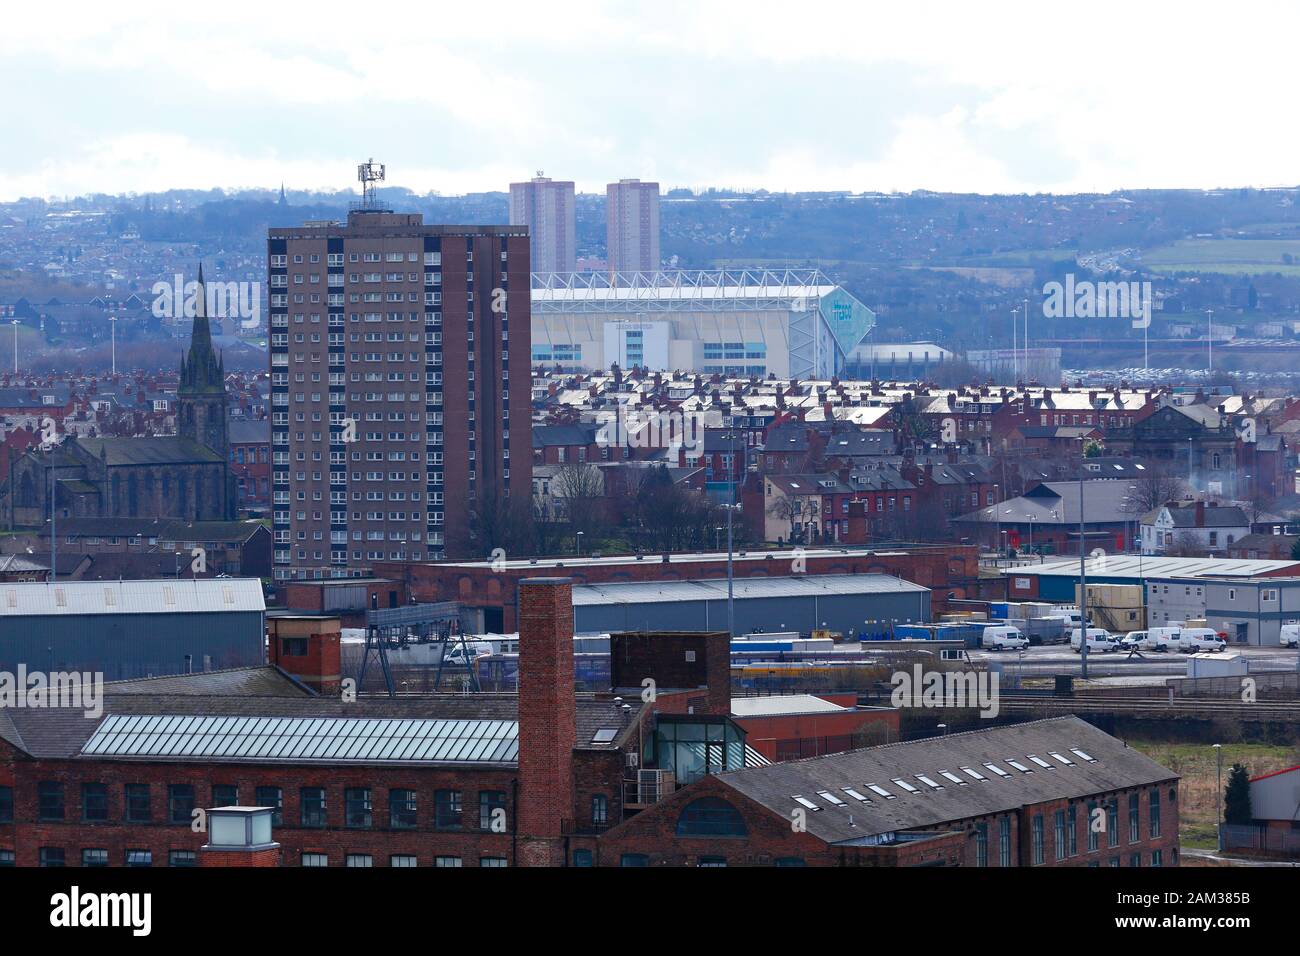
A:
[0, 578, 267, 680]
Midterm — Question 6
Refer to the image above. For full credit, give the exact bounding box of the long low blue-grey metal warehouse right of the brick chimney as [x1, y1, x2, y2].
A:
[573, 575, 930, 635]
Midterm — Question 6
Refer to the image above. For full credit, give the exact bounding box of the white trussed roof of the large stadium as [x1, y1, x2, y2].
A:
[532, 269, 839, 312]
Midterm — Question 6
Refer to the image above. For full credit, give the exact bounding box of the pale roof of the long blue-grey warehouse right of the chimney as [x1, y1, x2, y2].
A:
[573, 575, 930, 607]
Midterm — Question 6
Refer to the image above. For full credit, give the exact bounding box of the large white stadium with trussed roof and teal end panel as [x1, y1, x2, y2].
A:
[532, 269, 875, 380]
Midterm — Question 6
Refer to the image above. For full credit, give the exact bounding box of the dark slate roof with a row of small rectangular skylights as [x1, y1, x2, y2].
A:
[718, 717, 1179, 843]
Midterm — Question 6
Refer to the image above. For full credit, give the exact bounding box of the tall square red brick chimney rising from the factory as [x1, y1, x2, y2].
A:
[517, 578, 577, 866]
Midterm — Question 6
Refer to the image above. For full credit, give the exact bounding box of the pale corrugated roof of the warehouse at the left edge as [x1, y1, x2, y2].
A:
[0, 578, 267, 619]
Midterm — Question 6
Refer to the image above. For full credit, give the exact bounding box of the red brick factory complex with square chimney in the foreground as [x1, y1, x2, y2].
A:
[0, 578, 1178, 866]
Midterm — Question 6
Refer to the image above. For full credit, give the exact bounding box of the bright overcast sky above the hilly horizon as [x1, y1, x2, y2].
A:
[0, 0, 1300, 199]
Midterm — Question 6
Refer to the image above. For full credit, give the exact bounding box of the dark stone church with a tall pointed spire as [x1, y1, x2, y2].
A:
[4, 265, 237, 528]
